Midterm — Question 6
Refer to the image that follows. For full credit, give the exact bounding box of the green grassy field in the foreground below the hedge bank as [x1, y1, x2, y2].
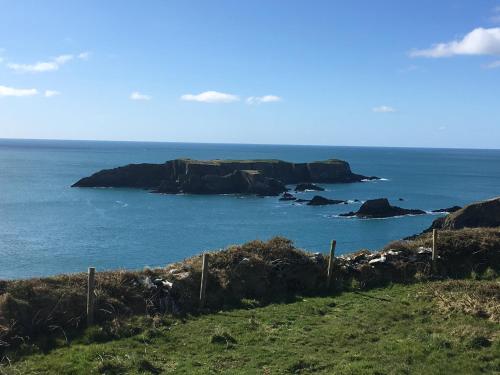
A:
[0, 275, 500, 375]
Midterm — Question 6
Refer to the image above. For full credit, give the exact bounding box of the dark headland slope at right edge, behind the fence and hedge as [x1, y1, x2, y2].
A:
[427, 197, 500, 231]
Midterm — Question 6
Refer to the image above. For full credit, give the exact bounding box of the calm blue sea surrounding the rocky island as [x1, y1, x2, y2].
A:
[0, 140, 500, 279]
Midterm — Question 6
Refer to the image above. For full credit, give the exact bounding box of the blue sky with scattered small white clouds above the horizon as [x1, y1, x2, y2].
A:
[0, 0, 500, 148]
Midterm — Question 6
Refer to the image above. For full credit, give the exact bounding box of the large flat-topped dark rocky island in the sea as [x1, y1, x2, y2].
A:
[73, 159, 375, 196]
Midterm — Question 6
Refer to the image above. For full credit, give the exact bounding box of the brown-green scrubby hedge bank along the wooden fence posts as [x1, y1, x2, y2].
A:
[0, 229, 500, 350]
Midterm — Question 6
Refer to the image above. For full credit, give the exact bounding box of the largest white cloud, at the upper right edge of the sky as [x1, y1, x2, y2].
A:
[410, 27, 500, 58]
